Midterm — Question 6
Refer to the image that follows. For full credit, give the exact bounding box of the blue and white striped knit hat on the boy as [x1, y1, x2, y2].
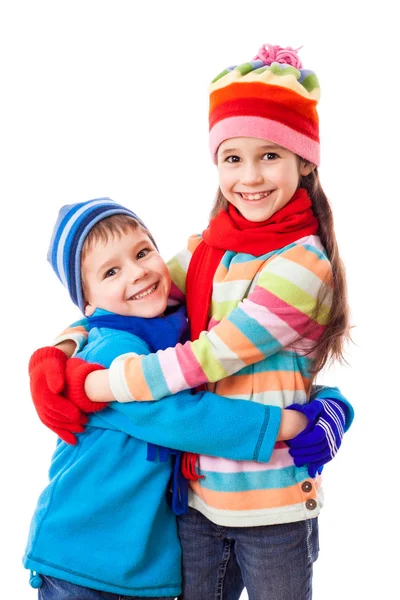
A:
[47, 198, 154, 312]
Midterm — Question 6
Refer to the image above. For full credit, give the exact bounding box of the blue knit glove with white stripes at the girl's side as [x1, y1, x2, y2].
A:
[286, 398, 347, 477]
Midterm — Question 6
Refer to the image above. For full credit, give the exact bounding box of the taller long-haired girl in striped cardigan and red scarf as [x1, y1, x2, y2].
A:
[29, 45, 352, 600]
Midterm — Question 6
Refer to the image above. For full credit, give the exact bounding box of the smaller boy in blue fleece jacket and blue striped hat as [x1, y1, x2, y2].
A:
[24, 198, 304, 600]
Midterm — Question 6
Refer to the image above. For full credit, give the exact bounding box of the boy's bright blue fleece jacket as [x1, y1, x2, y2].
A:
[24, 311, 281, 597]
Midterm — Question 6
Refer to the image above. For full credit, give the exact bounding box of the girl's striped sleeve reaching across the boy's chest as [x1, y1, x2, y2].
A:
[110, 238, 332, 402]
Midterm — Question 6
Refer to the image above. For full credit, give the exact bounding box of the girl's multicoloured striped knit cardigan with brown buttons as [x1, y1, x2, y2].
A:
[60, 236, 351, 526]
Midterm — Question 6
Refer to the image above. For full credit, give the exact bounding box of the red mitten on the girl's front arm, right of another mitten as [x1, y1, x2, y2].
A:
[64, 358, 108, 413]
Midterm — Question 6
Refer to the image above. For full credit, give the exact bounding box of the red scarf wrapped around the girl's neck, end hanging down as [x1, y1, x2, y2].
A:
[182, 188, 318, 479]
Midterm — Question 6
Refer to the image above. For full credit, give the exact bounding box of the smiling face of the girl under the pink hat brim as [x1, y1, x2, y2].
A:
[217, 137, 314, 222]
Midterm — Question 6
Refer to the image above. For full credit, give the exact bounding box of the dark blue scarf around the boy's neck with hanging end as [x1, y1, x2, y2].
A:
[87, 306, 189, 515]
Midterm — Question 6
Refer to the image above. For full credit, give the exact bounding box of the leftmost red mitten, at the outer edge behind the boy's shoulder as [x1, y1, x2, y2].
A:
[29, 346, 87, 444]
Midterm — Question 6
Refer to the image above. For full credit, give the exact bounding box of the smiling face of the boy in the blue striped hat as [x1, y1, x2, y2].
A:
[82, 228, 171, 319]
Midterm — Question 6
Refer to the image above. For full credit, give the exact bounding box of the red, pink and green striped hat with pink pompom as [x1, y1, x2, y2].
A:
[209, 44, 320, 166]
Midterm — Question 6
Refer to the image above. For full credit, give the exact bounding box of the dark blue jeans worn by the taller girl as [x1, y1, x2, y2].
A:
[178, 508, 319, 600]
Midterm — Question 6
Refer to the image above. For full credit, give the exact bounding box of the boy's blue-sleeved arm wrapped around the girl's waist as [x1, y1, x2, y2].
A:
[72, 330, 307, 462]
